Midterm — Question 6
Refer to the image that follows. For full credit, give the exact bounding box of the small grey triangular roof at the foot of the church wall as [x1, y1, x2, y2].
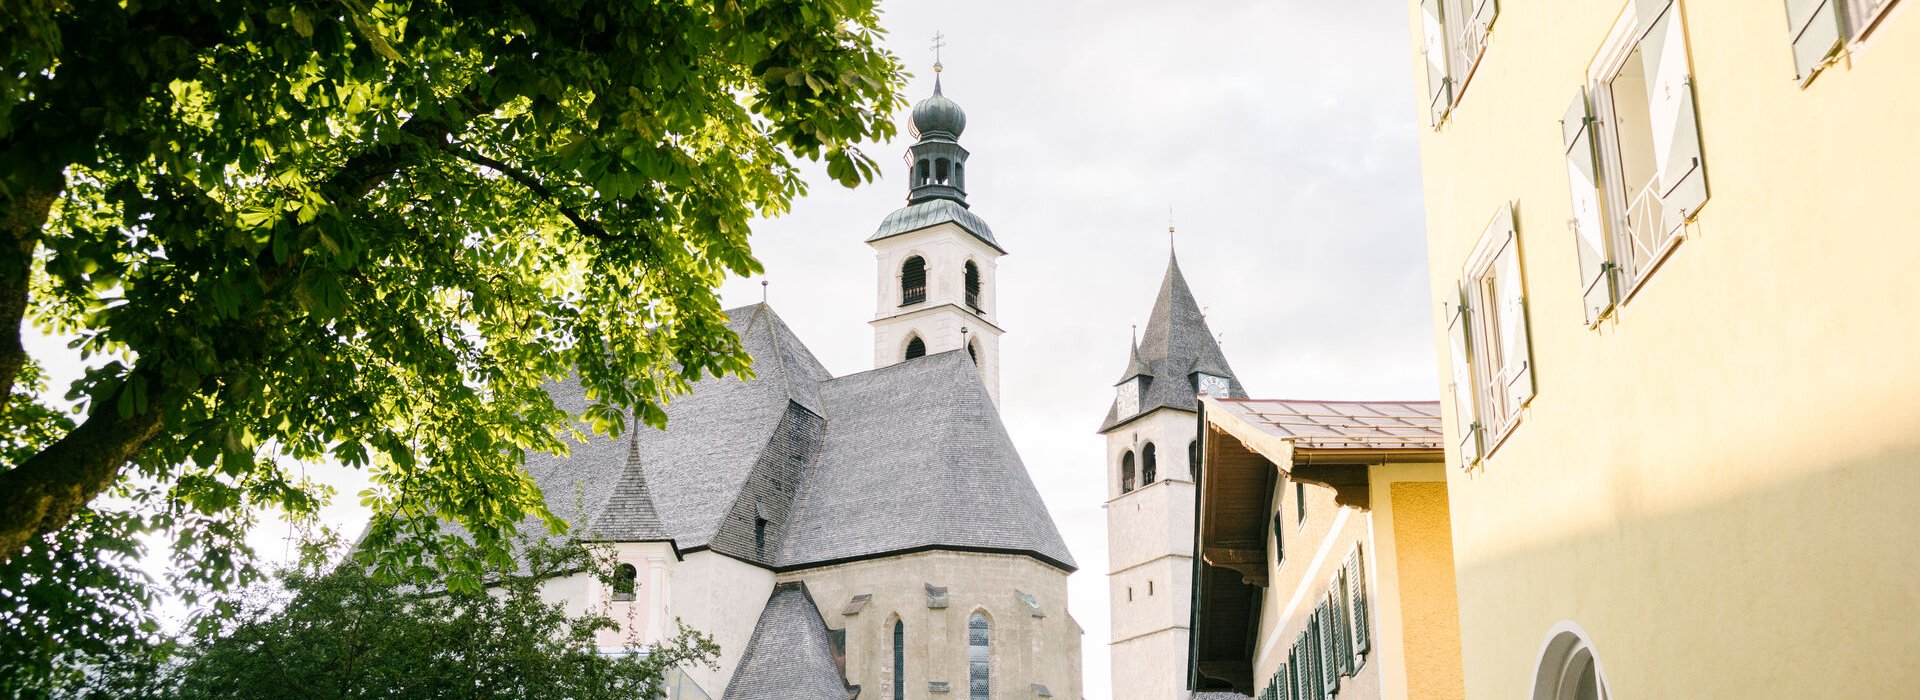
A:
[722, 583, 854, 700]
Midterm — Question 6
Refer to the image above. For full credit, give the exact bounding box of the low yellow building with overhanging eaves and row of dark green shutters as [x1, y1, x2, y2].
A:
[1187, 397, 1463, 700]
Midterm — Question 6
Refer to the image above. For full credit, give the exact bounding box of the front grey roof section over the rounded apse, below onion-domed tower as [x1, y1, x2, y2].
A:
[781, 349, 1073, 572]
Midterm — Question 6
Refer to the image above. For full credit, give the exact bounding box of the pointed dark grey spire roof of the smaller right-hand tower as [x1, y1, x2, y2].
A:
[1100, 245, 1246, 433]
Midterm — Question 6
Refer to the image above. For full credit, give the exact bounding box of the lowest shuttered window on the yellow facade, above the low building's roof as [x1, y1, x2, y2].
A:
[1448, 205, 1534, 466]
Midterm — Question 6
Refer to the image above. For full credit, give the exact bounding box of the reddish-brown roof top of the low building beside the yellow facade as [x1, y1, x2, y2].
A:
[1208, 399, 1444, 449]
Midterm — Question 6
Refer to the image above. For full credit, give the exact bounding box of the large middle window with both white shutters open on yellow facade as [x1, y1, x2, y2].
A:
[1561, 0, 1707, 324]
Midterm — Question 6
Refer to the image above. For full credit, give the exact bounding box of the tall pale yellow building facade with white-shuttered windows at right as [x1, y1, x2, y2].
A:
[1407, 0, 1920, 698]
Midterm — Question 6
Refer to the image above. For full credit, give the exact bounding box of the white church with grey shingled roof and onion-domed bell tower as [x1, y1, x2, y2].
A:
[526, 65, 1081, 700]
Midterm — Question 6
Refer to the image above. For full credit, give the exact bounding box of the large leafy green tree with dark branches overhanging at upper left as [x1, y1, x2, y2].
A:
[0, 0, 902, 591]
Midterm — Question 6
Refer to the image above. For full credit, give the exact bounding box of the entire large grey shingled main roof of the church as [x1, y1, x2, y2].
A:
[526, 305, 1073, 572]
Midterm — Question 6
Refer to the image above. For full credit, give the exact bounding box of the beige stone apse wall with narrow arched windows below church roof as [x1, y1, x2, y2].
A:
[780, 552, 1081, 698]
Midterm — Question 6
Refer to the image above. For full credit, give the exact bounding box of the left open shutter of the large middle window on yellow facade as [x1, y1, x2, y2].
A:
[1561, 88, 1613, 326]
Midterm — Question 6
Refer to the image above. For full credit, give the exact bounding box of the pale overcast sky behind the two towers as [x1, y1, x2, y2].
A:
[724, 0, 1438, 698]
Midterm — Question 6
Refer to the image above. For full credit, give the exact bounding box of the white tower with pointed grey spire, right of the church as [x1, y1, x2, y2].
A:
[1100, 255, 1246, 700]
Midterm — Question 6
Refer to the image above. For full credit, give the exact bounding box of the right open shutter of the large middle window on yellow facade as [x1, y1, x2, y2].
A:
[1640, 2, 1707, 234]
